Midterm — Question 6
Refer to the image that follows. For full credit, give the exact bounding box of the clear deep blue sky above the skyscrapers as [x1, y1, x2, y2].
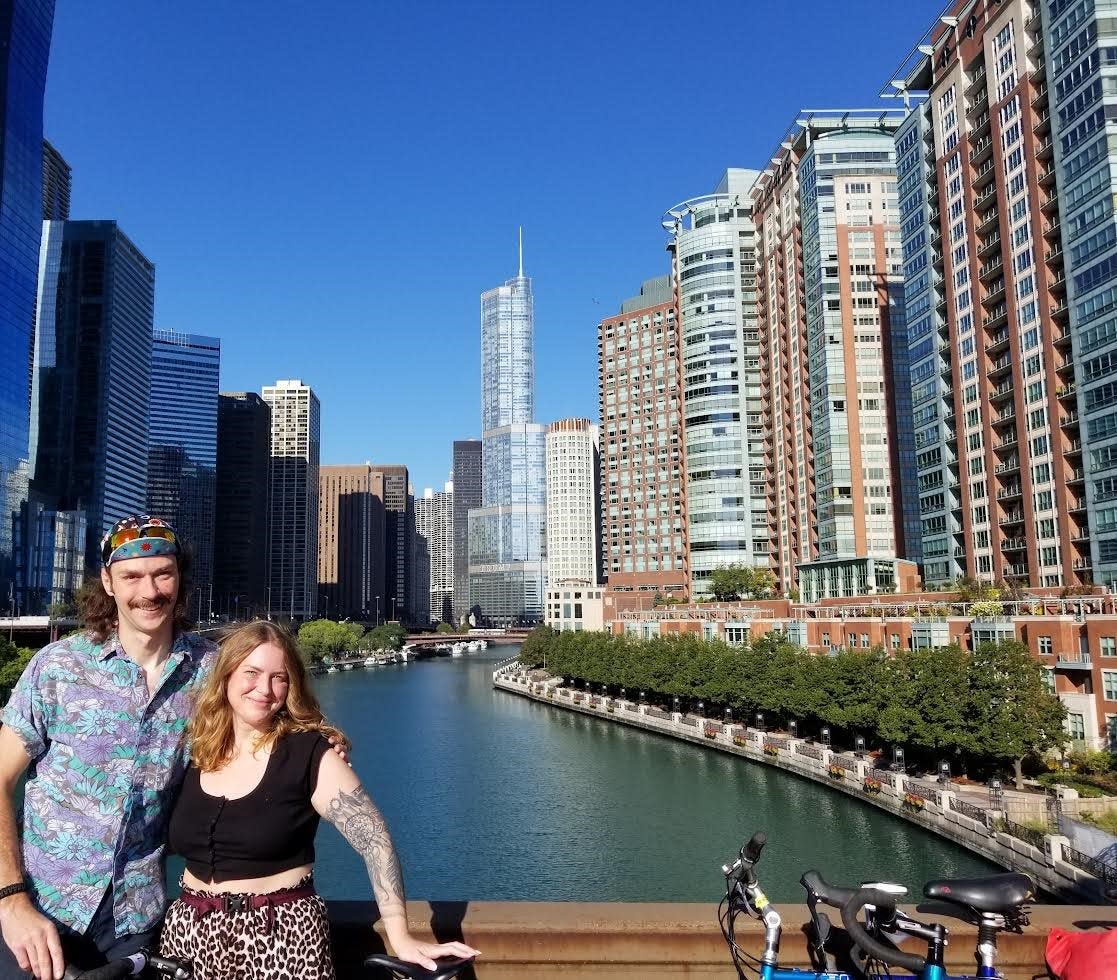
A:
[46, 0, 943, 493]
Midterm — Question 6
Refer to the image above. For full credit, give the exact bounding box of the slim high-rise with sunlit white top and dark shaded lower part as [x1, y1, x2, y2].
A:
[262, 379, 321, 620]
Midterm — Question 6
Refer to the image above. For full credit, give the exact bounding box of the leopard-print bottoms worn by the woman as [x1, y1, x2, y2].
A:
[160, 878, 334, 980]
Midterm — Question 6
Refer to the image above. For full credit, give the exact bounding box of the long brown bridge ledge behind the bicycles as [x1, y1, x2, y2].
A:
[330, 901, 1117, 980]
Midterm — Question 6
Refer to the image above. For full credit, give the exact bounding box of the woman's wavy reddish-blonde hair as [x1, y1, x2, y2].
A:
[190, 620, 350, 772]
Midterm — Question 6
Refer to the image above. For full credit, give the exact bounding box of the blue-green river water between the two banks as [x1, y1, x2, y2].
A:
[314, 646, 997, 902]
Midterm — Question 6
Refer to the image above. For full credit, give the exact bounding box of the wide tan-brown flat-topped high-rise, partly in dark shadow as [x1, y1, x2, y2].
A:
[318, 463, 384, 622]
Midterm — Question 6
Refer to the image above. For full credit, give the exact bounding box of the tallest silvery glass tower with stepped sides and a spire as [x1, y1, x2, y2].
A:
[469, 244, 546, 626]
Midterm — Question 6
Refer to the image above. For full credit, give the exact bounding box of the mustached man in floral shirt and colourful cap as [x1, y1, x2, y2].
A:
[0, 515, 216, 980]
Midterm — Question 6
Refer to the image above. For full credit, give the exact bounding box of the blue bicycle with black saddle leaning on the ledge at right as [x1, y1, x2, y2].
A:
[718, 834, 1034, 980]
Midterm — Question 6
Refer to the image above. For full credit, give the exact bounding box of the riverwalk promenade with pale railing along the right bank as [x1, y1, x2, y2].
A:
[493, 662, 1117, 907]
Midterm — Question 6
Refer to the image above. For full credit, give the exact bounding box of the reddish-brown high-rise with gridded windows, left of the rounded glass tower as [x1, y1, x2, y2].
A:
[598, 276, 690, 598]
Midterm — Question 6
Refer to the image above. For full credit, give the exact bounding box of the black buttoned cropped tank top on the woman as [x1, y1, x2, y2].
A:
[168, 732, 330, 882]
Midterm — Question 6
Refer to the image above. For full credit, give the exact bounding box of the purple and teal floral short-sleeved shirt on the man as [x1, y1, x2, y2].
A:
[0, 632, 216, 936]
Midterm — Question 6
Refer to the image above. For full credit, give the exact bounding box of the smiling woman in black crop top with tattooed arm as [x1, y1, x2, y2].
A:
[161, 622, 477, 980]
